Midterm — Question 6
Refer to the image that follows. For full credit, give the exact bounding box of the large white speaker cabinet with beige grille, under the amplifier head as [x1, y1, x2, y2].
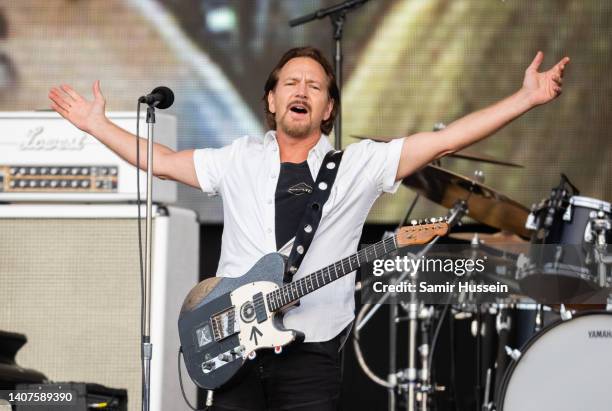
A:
[0, 204, 199, 411]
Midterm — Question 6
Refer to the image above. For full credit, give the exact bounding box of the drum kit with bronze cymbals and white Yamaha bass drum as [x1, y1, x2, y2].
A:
[353, 137, 612, 411]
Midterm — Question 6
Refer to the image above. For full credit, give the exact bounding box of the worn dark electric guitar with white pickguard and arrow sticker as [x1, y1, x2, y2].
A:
[178, 219, 448, 390]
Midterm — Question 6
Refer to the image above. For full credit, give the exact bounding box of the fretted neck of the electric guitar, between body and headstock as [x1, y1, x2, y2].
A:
[266, 236, 398, 311]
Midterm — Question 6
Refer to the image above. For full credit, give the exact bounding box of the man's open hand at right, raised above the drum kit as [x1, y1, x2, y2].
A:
[523, 51, 570, 106]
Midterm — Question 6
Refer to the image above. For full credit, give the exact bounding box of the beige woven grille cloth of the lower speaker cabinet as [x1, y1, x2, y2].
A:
[0, 218, 149, 410]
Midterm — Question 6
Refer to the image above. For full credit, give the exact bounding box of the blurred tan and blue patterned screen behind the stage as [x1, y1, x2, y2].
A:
[0, 0, 612, 222]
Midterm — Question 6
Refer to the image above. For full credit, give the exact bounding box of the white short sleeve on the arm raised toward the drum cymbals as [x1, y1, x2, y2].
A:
[354, 138, 404, 193]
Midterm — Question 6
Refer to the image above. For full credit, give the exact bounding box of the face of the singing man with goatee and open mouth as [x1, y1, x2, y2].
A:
[268, 57, 333, 138]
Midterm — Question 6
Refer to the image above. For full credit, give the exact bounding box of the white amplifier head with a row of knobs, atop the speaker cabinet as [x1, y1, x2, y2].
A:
[0, 112, 177, 204]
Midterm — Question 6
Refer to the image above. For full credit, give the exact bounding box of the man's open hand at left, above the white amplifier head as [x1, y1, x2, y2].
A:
[49, 80, 107, 133]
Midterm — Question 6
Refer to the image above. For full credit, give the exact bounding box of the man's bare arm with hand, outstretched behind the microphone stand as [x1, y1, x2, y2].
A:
[49, 81, 199, 188]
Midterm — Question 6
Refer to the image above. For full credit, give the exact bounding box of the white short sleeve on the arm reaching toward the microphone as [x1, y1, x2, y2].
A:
[193, 144, 235, 194]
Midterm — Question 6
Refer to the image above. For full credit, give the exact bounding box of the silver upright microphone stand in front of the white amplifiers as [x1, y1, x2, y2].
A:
[138, 102, 157, 411]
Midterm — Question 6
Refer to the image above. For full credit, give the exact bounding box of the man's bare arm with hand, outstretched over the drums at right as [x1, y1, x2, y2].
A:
[396, 51, 570, 180]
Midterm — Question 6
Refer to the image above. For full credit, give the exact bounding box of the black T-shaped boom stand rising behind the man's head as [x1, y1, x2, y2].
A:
[289, 0, 368, 150]
